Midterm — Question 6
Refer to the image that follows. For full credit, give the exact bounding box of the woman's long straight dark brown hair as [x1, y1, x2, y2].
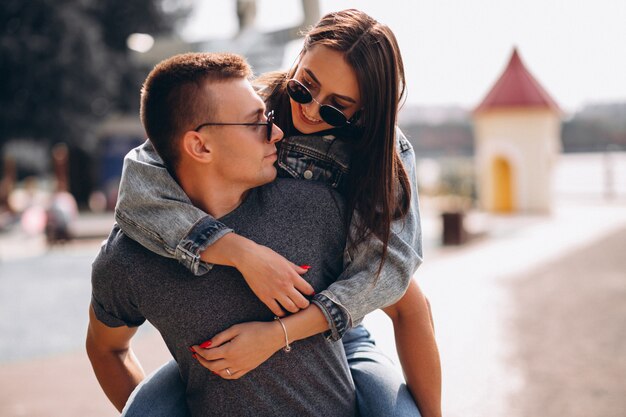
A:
[258, 9, 411, 273]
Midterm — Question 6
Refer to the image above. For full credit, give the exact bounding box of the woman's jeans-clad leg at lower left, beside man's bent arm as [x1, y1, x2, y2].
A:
[121, 360, 190, 417]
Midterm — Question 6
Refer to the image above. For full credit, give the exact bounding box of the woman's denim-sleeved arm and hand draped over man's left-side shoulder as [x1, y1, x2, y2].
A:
[115, 141, 313, 316]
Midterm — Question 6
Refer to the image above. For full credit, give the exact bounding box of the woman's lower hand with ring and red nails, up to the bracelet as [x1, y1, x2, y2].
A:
[190, 321, 285, 379]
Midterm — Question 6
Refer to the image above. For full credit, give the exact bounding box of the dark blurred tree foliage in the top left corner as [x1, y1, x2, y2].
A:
[0, 0, 189, 148]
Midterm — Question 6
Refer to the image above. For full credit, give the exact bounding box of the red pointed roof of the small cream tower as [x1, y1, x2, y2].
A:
[475, 48, 561, 113]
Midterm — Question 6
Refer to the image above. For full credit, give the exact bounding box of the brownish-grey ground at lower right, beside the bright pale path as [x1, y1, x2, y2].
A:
[510, 226, 626, 417]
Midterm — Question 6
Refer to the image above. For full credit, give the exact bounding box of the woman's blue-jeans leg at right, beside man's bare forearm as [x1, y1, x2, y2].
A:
[342, 325, 420, 417]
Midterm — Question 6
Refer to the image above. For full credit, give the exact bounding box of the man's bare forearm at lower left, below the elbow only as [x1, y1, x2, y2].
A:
[87, 341, 145, 412]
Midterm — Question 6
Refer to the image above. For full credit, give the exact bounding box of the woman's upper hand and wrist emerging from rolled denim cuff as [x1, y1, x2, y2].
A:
[202, 233, 315, 317]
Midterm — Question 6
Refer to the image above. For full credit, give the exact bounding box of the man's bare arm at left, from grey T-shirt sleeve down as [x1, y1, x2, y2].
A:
[86, 306, 145, 412]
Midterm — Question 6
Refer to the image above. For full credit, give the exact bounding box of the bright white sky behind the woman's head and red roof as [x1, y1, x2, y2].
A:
[181, 0, 626, 112]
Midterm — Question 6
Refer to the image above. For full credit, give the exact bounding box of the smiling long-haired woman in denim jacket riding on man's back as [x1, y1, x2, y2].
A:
[116, 10, 440, 416]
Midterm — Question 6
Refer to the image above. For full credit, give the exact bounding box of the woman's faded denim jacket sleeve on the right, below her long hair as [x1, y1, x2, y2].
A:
[313, 129, 422, 340]
